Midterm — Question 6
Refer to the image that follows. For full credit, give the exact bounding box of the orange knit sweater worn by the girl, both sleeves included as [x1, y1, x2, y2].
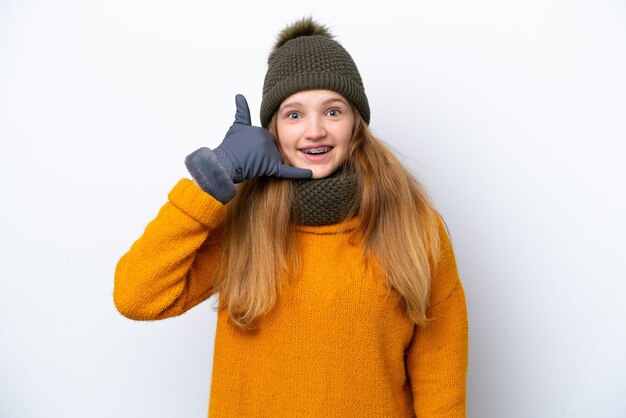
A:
[114, 179, 467, 418]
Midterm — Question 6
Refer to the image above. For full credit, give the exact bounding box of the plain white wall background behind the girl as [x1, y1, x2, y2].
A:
[0, 0, 626, 418]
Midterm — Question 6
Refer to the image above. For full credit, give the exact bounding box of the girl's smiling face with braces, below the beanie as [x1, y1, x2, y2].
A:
[276, 90, 354, 179]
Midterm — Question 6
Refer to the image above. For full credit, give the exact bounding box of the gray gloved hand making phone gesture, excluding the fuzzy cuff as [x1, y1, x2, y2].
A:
[213, 94, 313, 183]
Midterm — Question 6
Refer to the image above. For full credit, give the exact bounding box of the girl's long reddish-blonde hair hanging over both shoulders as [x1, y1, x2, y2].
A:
[214, 108, 439, 330]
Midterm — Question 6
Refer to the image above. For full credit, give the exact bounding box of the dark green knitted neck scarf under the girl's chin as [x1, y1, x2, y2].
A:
[295, 167, 358, 226]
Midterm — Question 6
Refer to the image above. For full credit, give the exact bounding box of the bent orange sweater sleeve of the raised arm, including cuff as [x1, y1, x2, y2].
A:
[113, 179, 225, 320]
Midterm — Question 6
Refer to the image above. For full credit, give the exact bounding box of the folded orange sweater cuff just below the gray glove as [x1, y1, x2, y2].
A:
[168, 179, 224, 227]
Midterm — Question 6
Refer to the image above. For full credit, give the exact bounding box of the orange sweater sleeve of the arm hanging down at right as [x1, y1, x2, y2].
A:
[407, 219, 468, 418]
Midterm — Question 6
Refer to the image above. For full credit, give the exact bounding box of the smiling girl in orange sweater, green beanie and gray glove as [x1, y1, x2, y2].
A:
[114, 19, 467, 418]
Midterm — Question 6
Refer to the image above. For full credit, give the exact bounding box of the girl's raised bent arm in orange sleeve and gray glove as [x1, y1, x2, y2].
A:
[113, 95, 312, 319]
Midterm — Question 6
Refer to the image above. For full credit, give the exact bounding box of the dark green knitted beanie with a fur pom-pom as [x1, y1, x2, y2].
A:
[261, 18, 370, 128]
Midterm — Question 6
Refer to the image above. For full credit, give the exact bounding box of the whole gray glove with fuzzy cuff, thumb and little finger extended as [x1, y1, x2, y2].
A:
[185, 94, 313, 204]
